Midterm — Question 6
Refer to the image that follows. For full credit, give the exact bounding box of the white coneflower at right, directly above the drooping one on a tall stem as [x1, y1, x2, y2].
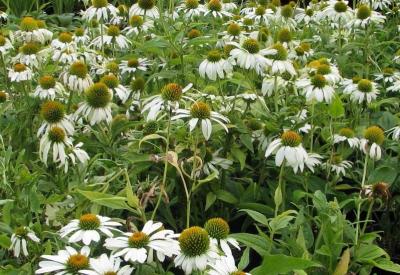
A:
[343, 79, 379, 103]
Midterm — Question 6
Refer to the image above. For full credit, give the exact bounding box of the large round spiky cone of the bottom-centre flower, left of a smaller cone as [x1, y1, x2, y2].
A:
[179, 226, 210, 257]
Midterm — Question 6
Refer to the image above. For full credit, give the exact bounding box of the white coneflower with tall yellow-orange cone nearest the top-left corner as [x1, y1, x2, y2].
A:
[15, 17, 46, 44]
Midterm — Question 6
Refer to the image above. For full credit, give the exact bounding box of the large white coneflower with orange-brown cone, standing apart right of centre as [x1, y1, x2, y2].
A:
[265, 131, 308, 173]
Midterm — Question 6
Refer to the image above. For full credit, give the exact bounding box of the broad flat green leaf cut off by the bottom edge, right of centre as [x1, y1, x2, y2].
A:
[251, 254, 321, 275]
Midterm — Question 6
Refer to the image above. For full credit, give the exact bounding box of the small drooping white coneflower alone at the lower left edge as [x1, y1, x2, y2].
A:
[9, 226, 40, 258]
